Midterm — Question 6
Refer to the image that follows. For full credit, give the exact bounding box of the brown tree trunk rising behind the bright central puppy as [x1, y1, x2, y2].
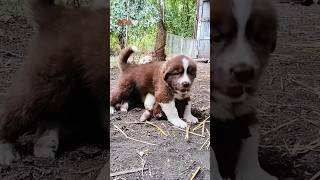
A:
[153, 0, 167, 61]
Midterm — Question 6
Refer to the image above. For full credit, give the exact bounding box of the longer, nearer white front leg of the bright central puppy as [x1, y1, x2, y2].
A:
[159, 100, 188, 128]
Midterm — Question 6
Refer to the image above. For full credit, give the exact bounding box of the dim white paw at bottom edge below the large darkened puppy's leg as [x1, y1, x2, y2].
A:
[236, 169, 278, 180]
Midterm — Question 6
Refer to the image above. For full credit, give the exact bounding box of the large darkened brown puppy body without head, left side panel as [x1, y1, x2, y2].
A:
[0, 0, 109, 164]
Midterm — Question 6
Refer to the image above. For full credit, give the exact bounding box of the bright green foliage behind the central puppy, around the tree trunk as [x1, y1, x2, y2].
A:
[110, 0, 197, 52]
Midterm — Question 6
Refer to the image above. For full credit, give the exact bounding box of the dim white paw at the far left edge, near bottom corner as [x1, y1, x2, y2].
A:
[0, 142, 19, 165]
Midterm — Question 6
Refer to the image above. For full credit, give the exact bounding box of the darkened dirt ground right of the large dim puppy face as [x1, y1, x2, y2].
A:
[259, 4, 320, 180]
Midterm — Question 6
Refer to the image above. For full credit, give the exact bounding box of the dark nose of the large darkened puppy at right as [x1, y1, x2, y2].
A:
[230, 64, 254, 83]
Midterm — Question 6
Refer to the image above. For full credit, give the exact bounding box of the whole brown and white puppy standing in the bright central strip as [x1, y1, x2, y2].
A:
[110, 47, 198, 128]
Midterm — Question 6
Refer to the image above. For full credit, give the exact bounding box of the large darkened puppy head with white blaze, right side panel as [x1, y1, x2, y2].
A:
[211, 0, 277, 102]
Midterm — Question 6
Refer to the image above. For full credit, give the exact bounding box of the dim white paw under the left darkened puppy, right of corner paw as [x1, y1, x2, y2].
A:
[33, 129, 59, 158]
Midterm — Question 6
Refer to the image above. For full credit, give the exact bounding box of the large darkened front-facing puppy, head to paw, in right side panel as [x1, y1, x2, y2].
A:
[211, 0, 277, 180]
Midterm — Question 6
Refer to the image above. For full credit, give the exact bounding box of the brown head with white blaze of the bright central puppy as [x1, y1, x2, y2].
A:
[162, 55, 197, 97]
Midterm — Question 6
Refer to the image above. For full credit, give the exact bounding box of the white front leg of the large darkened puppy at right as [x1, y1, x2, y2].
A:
[236, 125, 277, 180]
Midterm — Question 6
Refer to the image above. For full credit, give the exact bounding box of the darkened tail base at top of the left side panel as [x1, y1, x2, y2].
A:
[27, 0, 61, 29]
